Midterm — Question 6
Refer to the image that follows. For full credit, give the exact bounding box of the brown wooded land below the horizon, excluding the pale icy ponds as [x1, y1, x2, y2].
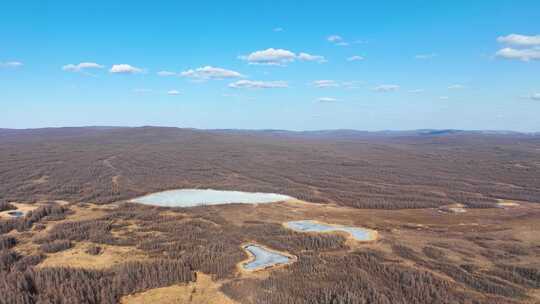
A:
[0, 128, 540, 304]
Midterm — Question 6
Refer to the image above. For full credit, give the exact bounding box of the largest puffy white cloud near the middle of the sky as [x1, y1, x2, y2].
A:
[239, 48, 326, 66]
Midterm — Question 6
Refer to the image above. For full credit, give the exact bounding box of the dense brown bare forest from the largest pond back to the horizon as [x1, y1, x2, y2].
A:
[0, 127, 540, 209]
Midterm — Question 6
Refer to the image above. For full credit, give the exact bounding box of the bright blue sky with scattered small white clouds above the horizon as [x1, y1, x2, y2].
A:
[0, 0, 540, 131]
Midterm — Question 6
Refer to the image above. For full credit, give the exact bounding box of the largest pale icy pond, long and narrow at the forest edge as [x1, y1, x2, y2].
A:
[131, 189, 292, 207]
